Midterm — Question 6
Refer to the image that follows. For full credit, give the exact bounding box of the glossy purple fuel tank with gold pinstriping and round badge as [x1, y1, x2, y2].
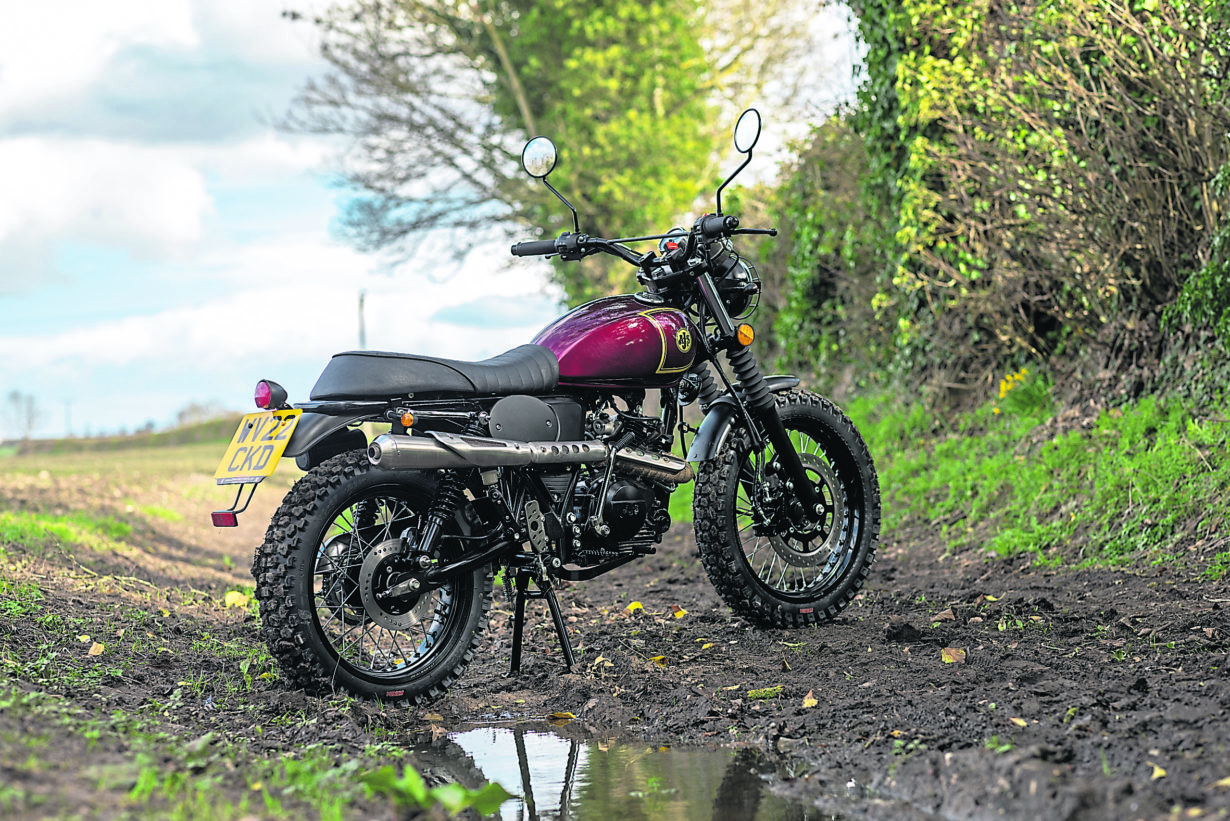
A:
[534, 297, 696, 388]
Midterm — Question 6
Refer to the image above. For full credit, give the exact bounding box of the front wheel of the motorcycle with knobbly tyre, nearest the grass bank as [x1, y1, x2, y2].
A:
[694, 390, 879, 627]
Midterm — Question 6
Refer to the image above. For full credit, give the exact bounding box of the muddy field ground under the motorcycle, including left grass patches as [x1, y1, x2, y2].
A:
[0, 446, 1230, 819]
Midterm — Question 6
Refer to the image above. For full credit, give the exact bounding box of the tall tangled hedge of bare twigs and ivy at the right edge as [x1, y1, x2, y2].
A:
[854, 0, 1230, 389]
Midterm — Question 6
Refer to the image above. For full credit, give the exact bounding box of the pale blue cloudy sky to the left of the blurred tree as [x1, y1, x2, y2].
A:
[0, 0, 849, 439]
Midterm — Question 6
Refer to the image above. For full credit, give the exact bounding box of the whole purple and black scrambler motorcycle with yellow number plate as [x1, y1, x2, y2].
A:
[213, 108, 879, 704]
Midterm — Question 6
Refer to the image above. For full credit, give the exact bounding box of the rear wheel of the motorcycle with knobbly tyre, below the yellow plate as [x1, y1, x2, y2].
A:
[252, 451, 492, 704]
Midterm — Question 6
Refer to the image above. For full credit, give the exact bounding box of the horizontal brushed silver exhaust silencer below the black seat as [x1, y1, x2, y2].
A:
[368, 431, 610, 470]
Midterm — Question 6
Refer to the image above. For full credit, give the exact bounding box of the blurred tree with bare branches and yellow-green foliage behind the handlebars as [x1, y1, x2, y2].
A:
[288, 0, 821, 302]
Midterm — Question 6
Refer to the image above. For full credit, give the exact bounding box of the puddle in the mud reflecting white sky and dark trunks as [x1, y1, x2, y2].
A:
[415, 725, 833, 821]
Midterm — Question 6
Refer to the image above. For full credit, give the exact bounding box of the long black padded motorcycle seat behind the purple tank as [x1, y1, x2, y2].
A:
[311, 345, 560, 401]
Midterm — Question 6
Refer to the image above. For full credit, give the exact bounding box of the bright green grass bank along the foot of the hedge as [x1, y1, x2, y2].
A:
[849, 391, 1230, 579]
